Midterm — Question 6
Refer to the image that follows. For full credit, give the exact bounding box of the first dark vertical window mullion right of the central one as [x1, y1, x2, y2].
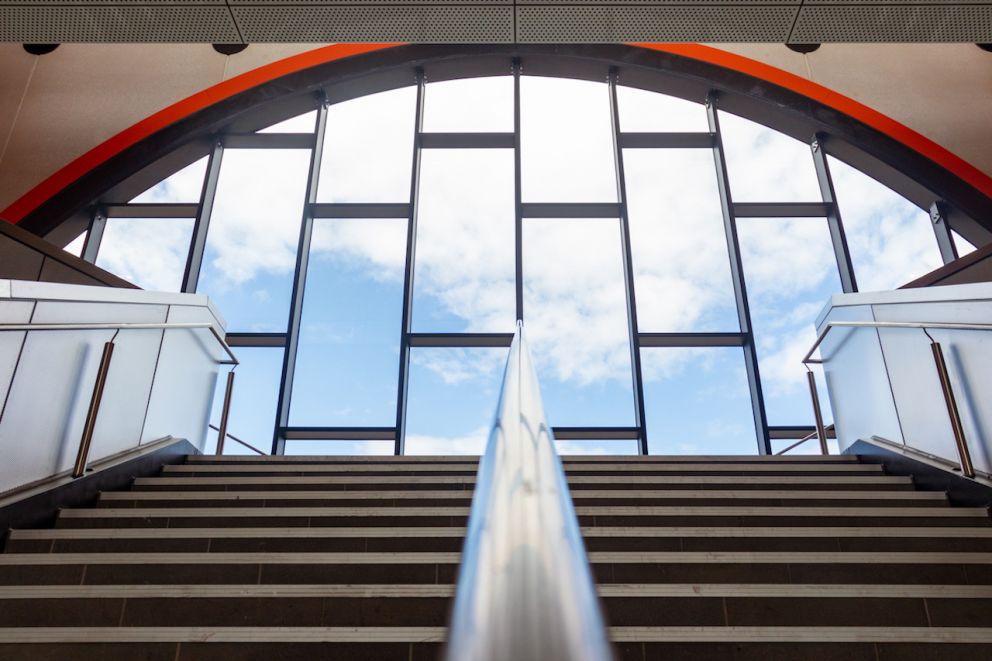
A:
[609, 69, 648, 454]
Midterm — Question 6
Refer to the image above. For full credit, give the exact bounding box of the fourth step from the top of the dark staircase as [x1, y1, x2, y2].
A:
[97, 488, 948, 508]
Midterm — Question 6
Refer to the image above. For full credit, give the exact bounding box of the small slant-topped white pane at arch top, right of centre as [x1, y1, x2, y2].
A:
[617, 85, 710, 133]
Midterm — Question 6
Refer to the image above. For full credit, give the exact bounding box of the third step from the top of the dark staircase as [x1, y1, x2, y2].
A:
[132, 474, 913, 491]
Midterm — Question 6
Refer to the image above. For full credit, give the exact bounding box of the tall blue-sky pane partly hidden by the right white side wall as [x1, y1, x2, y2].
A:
[737, 218, 841, 425]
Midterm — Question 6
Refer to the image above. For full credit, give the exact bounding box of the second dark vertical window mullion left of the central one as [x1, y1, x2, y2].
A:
[272, 100, 328, 454]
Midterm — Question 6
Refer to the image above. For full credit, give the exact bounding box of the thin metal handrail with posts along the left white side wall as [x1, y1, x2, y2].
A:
[0, 322, 240, 478]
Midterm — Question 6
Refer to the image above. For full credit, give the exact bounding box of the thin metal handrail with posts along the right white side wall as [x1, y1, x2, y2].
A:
[802, 321, 992, 477]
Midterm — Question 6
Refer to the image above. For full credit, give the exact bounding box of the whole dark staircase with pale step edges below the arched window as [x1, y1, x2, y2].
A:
[0, 456, 992, 661]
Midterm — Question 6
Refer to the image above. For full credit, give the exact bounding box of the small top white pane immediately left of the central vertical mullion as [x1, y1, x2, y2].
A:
[424, 76, 513, 133]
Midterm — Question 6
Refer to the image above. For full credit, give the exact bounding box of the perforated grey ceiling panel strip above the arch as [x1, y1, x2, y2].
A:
[0, 0, 992, 43]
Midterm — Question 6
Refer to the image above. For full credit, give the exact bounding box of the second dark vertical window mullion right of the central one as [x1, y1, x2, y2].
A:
[706, 92, 772, 454]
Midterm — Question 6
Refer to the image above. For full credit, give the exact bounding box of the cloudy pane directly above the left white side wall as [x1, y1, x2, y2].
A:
[96, 218, 193, 291]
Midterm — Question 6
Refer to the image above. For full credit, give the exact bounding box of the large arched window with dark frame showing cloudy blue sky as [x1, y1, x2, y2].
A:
[19, 45, 983, 454]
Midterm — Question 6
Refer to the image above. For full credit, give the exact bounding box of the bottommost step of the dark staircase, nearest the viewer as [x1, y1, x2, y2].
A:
[0, 627, 992, 661]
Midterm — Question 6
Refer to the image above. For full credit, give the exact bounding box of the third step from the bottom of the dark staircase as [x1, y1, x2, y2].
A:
[0, 551, 992, 585]
